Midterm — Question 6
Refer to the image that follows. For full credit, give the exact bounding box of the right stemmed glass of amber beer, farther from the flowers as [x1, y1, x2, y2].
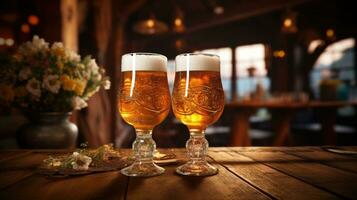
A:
[172, 53, 224, 176]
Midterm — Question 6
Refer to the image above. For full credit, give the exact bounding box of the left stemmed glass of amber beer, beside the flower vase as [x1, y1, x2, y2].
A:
[118, 53, 170, 176]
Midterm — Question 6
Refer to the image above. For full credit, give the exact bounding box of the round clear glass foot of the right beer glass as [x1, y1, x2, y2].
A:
[176, 161, 218, 176]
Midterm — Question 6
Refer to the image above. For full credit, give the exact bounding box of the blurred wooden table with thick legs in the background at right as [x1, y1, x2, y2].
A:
[226, 101, 357, 146]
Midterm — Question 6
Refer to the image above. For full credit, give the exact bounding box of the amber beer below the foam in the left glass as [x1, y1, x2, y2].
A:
[118, 71, 170, 130]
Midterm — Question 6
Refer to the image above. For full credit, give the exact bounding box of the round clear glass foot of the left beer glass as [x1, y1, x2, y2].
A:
[120, 162, 165, 177]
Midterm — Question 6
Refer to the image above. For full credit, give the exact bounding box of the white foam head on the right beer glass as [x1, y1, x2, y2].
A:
[176, 53, 220, 72]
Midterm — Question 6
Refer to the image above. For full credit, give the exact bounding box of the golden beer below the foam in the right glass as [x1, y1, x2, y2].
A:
[172, 71, 224, 130]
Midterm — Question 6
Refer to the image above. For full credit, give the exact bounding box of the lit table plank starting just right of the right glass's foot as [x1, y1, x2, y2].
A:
[209, 152, 338, 199]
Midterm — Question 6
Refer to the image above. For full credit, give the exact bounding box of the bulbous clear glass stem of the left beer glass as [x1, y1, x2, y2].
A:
[133, 130, 156, 162]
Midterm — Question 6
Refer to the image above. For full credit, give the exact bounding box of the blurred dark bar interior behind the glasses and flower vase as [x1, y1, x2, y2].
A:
[0, 0, 357, 149]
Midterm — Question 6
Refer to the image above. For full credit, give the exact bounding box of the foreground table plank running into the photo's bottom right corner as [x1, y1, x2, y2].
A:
[237, 151, 357, 199]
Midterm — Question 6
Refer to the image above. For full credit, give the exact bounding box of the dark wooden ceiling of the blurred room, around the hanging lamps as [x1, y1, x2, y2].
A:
[0, 0, 357, 55]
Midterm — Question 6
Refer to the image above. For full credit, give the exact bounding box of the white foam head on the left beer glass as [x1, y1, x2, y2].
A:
[121, 53, 167, 72]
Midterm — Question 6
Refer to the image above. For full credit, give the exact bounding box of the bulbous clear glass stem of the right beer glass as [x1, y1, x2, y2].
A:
[186, 130, 208, 163]
